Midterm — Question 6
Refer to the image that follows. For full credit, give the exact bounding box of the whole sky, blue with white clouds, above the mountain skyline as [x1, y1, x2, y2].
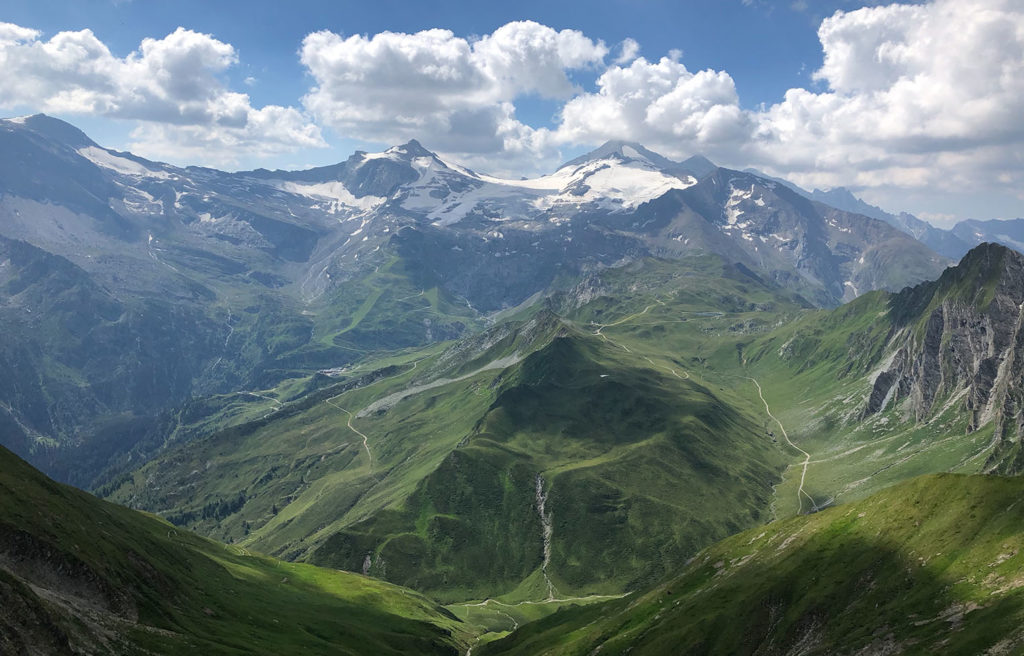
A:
[0, 0, 1024, 226]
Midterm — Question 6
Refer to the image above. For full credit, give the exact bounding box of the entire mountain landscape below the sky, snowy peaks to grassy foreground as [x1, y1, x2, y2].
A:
[0, 115, 1024, 654]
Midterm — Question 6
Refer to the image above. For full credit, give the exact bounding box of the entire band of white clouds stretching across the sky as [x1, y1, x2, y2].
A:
[8, 5, 1024, 213]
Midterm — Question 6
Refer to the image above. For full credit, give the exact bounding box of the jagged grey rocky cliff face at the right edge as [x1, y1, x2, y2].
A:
[864, 244, 1024, 472]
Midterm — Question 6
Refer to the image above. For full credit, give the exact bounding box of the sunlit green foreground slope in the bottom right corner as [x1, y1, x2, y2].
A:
[483, 475, 1024, 656]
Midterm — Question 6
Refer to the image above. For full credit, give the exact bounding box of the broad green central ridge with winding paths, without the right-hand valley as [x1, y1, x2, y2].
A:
[104, 257, 800, 601]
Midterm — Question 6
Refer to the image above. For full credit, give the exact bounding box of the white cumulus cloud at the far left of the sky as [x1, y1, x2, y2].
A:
[0, 24, 324, 164]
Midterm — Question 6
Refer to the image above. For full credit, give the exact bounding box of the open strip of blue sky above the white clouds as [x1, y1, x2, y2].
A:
[0, 0, 839, 105]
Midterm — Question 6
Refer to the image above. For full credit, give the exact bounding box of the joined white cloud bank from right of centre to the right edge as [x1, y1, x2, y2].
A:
[540, 0, 1024, 219]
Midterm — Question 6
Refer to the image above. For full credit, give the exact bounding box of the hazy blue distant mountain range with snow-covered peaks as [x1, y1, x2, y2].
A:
[0, 115, 947, 474]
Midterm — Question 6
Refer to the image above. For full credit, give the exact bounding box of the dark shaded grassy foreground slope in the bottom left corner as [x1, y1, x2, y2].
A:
[0, 447, 465, 655]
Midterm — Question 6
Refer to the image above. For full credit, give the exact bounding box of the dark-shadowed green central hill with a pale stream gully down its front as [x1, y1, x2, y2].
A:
[312, 330, 783, 599]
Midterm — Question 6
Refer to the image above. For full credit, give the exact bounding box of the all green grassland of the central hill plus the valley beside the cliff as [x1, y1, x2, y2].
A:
[103, 250, 1015, 625]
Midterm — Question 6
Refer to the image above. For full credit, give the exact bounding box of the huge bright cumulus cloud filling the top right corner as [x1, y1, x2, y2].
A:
[744, 0, 1024, 199]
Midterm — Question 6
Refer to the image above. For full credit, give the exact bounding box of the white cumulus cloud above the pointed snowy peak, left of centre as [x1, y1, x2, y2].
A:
[300, 20, 608, 171]
